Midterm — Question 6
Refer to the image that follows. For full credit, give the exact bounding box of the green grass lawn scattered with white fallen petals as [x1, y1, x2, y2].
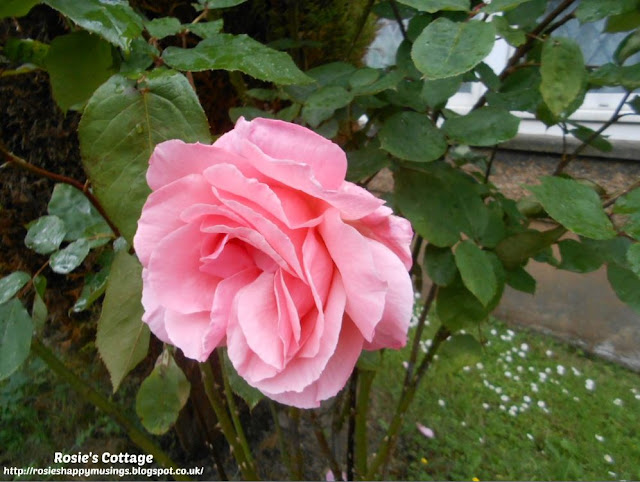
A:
[376, 320, 640, 480]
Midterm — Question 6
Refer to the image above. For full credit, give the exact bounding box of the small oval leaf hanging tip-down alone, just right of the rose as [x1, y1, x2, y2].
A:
[455, 240, 498, 306]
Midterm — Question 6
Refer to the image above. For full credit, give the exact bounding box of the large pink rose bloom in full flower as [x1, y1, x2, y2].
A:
[134, 118, 413, 408]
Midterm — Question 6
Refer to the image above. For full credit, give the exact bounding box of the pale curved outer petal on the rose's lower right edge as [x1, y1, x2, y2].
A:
[365, 240, 413, 350]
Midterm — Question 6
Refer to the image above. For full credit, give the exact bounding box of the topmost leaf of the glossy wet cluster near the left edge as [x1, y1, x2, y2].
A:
[47, 184, 111, 241]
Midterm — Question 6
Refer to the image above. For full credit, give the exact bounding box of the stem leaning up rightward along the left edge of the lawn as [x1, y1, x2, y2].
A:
[365, 326, 451, 480]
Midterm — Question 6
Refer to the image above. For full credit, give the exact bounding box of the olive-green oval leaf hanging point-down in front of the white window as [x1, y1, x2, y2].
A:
[540, 37, 587, 116]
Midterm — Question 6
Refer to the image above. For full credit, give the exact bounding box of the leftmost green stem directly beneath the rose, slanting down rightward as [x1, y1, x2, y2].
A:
[200, 362, 258, 480]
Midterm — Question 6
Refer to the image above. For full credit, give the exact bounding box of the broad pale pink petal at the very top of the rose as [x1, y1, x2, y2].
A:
[215, 117, 347, 190]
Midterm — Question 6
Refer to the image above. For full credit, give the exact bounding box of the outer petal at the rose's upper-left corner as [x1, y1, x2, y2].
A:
[147, 139, 254, 191]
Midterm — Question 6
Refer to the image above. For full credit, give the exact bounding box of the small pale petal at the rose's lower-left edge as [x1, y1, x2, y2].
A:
[164, 310, 213, 362]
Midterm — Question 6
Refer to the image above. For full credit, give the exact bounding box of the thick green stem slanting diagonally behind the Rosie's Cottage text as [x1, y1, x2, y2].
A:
[31, 337, 191, 480]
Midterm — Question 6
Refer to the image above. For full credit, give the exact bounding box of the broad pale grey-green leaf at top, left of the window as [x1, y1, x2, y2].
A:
[411, 18, 495, 79]
